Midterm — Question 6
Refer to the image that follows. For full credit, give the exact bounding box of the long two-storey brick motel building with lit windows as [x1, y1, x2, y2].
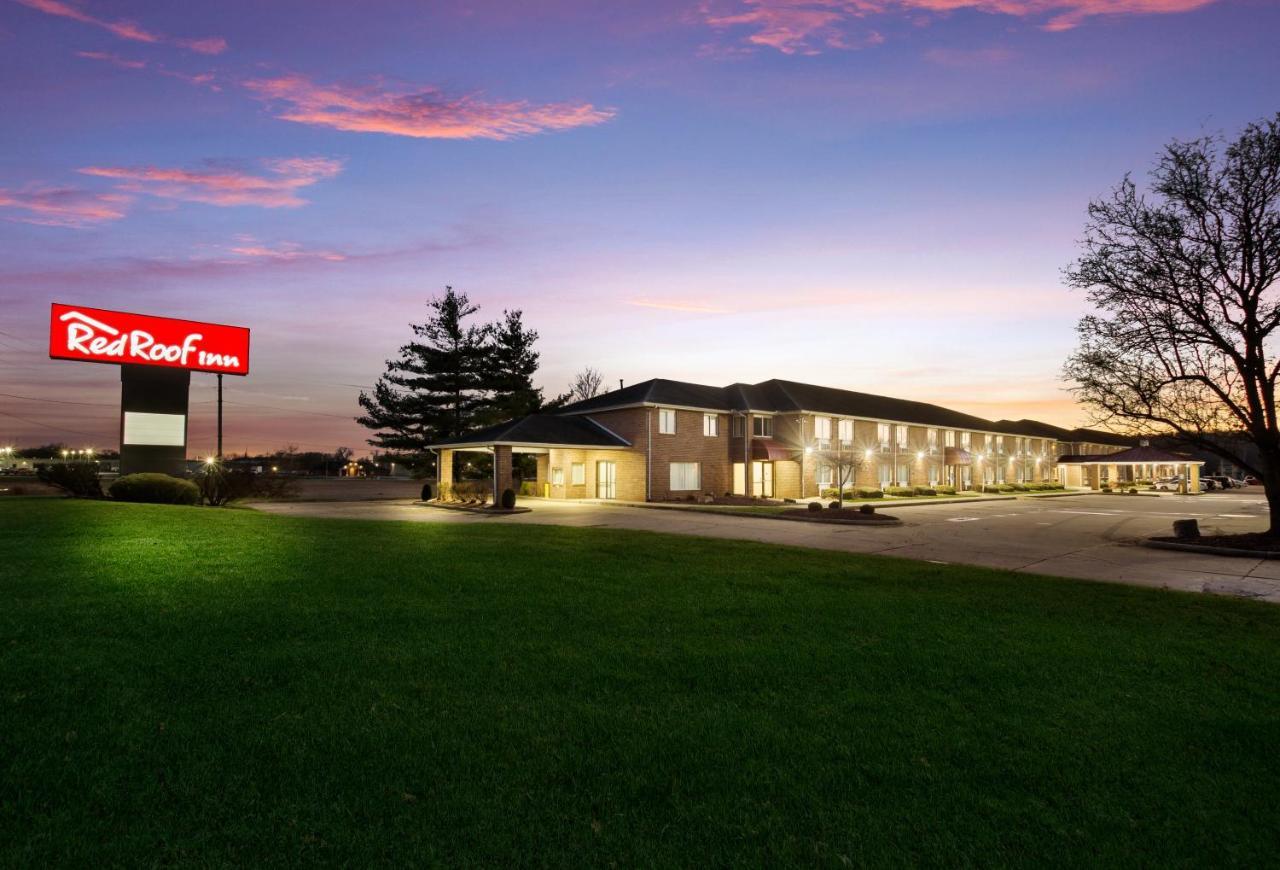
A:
[433, 379, 1194, 502]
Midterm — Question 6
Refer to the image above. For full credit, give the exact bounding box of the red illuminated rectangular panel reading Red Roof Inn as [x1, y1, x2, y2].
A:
[49, 302, 248, 375]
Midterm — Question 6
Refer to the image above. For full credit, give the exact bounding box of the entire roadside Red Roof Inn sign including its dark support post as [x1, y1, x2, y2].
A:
[49, 302, 250, 475]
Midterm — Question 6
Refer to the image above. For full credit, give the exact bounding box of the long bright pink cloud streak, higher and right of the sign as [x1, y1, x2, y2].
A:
[244, 75, 614, 139]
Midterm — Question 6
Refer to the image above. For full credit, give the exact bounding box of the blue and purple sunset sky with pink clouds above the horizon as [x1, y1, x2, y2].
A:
[0, 0, 1280, 455]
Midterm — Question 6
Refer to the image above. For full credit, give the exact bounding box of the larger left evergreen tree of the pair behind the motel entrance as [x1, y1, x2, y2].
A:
[356, 287, 488, 452]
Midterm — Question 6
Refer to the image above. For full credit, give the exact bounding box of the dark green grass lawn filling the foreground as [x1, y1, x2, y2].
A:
[0, 499, 1280, 866]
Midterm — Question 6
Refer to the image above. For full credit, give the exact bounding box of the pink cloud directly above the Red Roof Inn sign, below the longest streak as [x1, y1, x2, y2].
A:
[79, 157, 342, 209]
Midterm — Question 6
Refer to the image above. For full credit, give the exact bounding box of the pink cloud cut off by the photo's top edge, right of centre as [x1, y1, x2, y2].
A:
[701, 0, 1216, 54]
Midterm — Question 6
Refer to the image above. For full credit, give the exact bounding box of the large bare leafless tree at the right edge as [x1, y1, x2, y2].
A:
[1065, 114, 1280, 536]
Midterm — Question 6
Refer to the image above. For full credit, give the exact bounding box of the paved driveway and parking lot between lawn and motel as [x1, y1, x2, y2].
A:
[253, 493, 1280, 603]
